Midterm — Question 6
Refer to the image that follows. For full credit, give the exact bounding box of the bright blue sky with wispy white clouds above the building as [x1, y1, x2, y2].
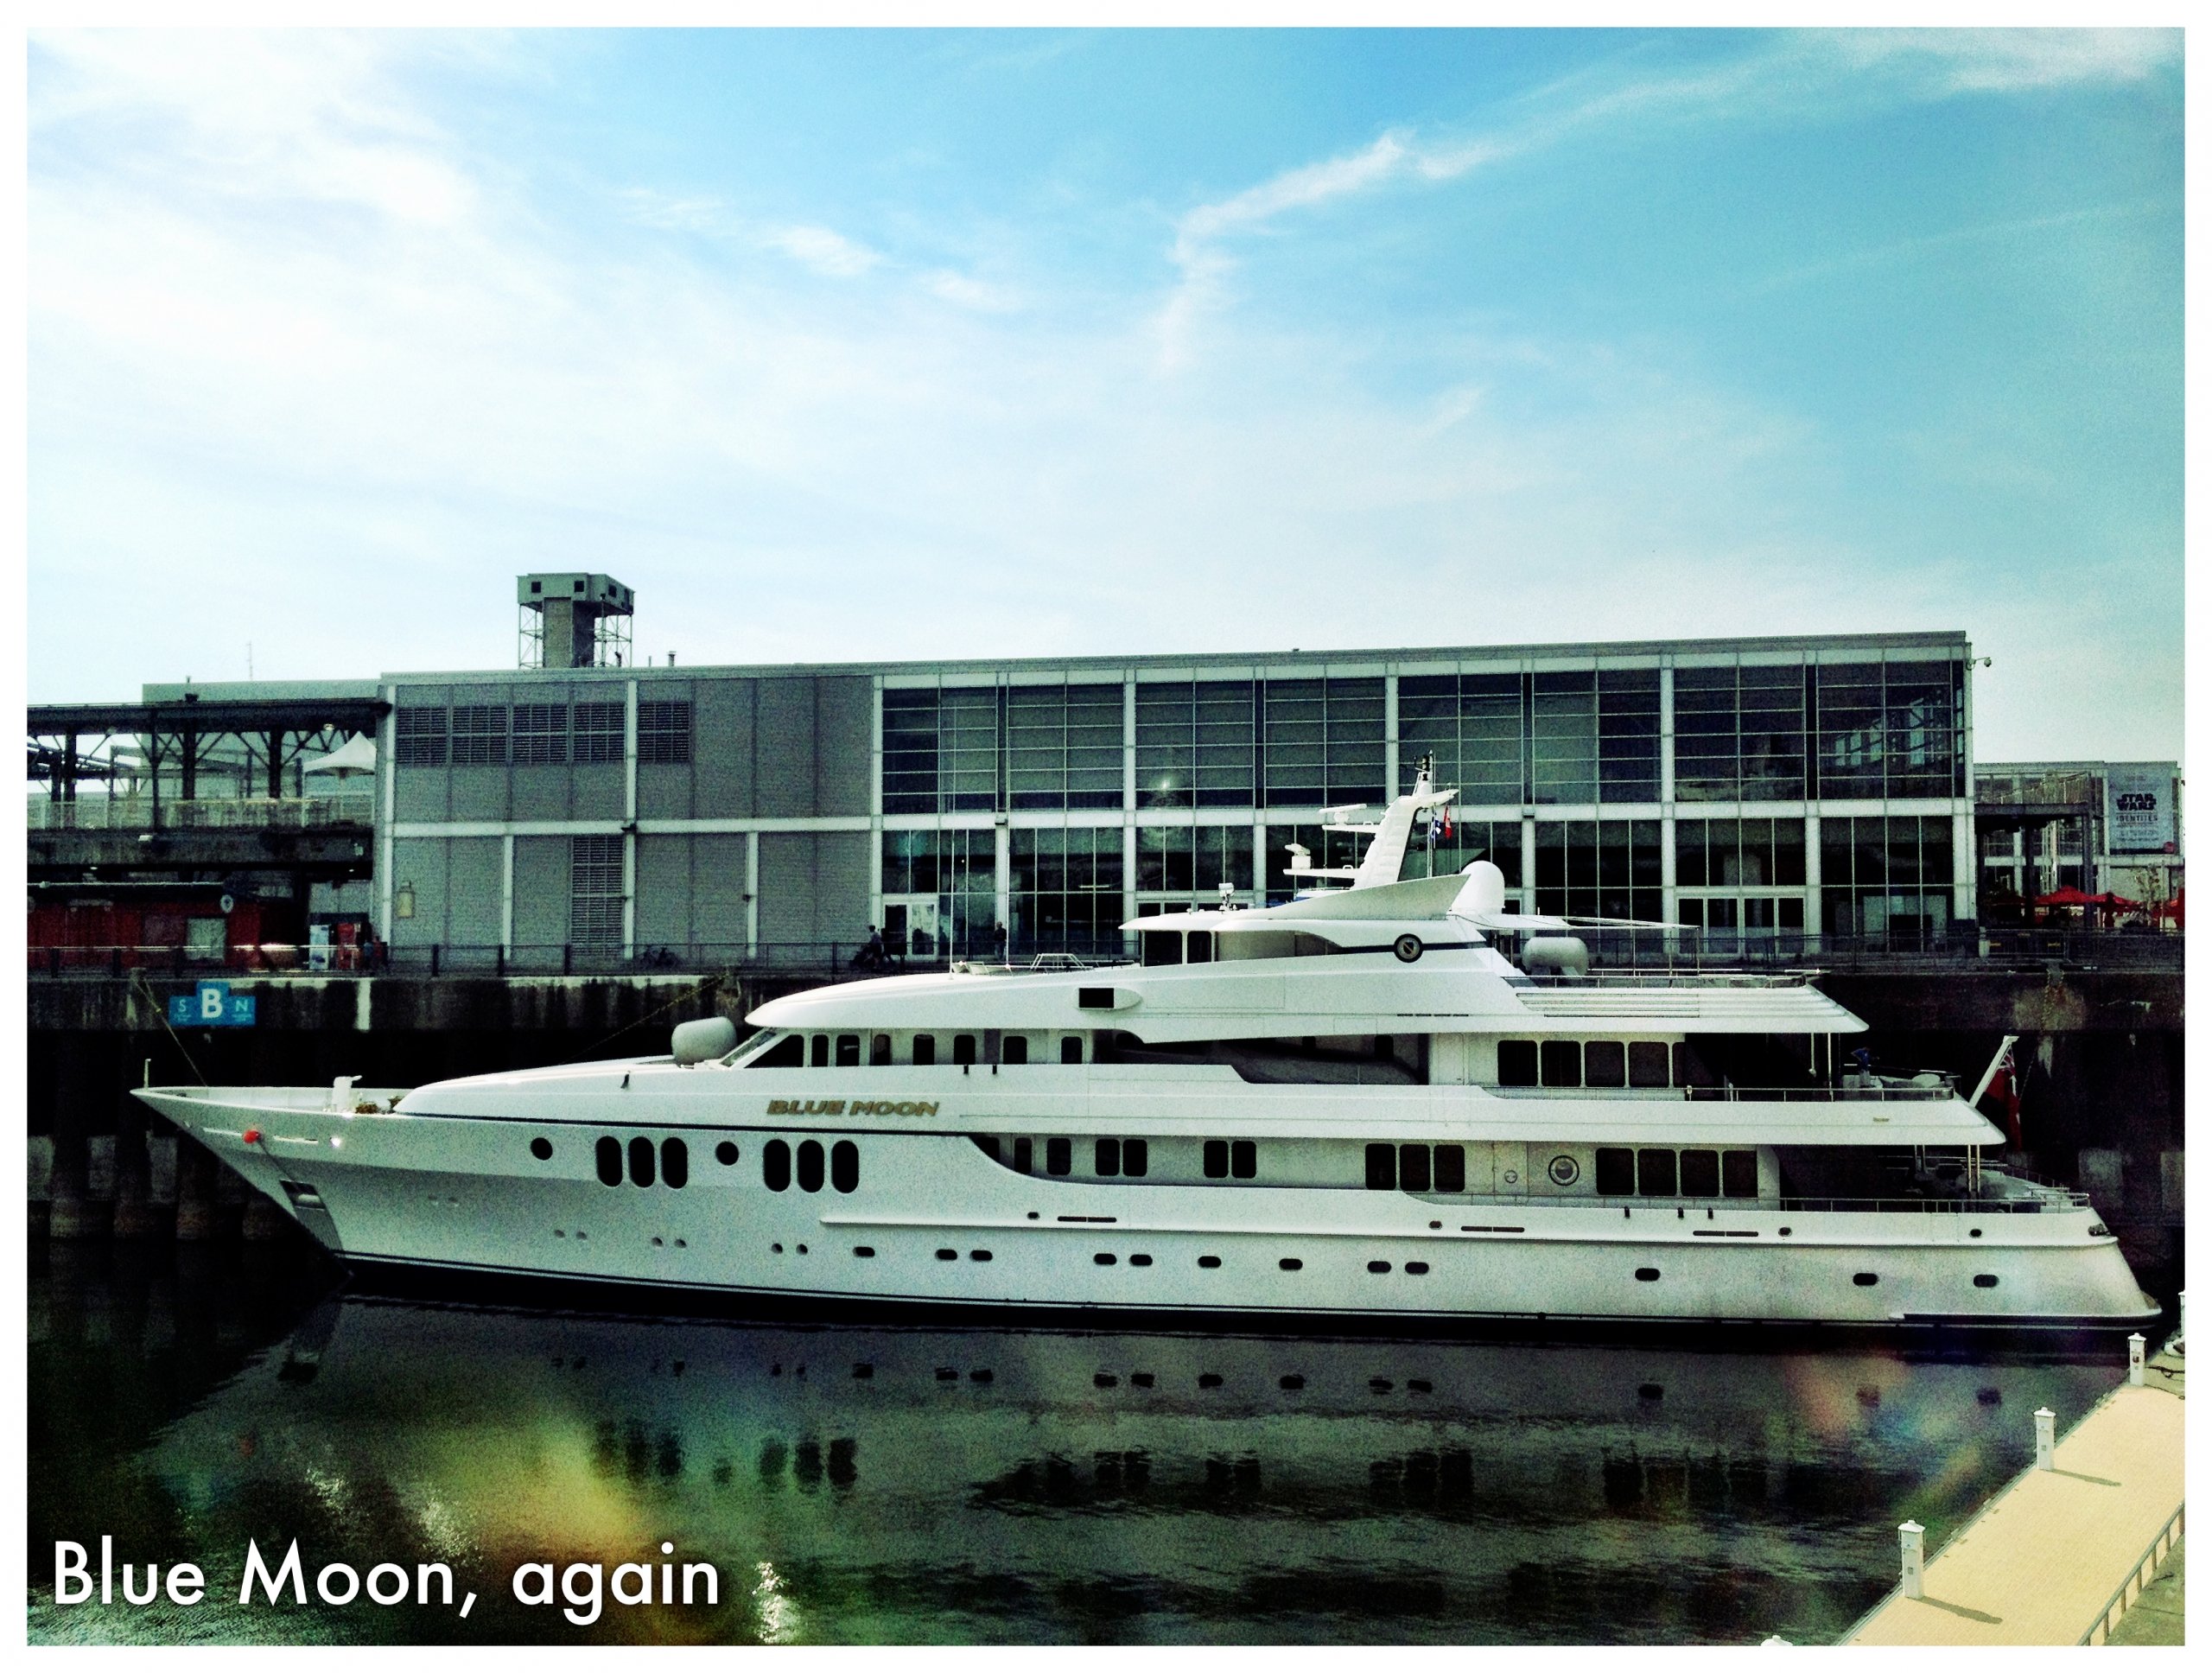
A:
[29, 31, 2183, 759]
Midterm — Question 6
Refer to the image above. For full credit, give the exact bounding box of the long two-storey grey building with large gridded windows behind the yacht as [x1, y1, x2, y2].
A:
[378, 633, 1986, 956]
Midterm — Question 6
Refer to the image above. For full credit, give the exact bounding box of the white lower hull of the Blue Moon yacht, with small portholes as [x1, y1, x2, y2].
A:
[139, 1089, 2159, 1330]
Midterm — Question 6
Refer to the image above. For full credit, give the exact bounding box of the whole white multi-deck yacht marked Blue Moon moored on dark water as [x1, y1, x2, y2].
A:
[139, 774, 2159, 1328]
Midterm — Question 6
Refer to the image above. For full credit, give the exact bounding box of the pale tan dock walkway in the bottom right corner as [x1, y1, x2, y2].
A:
[1845, 1354, 2183, 1644]
